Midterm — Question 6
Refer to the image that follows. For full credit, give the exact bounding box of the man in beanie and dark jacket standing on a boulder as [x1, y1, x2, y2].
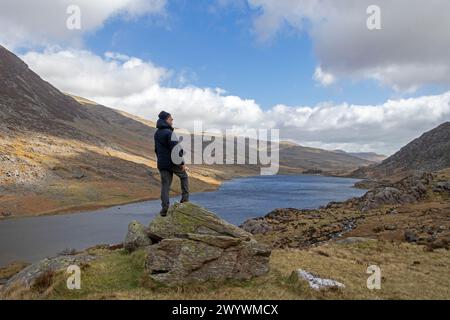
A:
[155, 111, 189, 217]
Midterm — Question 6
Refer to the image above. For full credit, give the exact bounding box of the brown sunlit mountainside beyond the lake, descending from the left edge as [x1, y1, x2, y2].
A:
[0, 46, 371, 217]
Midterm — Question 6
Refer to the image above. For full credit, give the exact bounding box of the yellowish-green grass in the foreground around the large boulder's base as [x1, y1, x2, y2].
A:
[33, 241, 450, 300]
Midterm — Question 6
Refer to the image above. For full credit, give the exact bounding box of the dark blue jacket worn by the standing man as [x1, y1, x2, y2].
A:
[155, 119, 184, 170]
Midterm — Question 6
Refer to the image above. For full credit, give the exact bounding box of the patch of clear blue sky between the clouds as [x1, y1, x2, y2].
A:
[85, 0, 440, 109]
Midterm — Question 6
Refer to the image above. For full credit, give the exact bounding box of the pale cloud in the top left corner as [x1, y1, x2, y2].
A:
[0, 0, 166, 48]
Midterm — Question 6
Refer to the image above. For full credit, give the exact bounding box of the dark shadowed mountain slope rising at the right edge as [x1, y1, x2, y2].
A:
[354, 122, 450, 180]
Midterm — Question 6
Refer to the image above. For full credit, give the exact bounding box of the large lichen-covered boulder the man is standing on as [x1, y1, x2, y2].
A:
[145, 203, 270, 286]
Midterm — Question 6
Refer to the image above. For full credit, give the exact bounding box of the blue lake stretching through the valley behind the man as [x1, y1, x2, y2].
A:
[0, 175, 365, 266]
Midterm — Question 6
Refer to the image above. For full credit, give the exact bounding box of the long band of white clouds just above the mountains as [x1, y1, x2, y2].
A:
[22, 49, 450, 154]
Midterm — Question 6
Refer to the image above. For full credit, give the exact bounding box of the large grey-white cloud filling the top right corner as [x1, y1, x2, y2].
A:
[248, 0, 450, 91]
